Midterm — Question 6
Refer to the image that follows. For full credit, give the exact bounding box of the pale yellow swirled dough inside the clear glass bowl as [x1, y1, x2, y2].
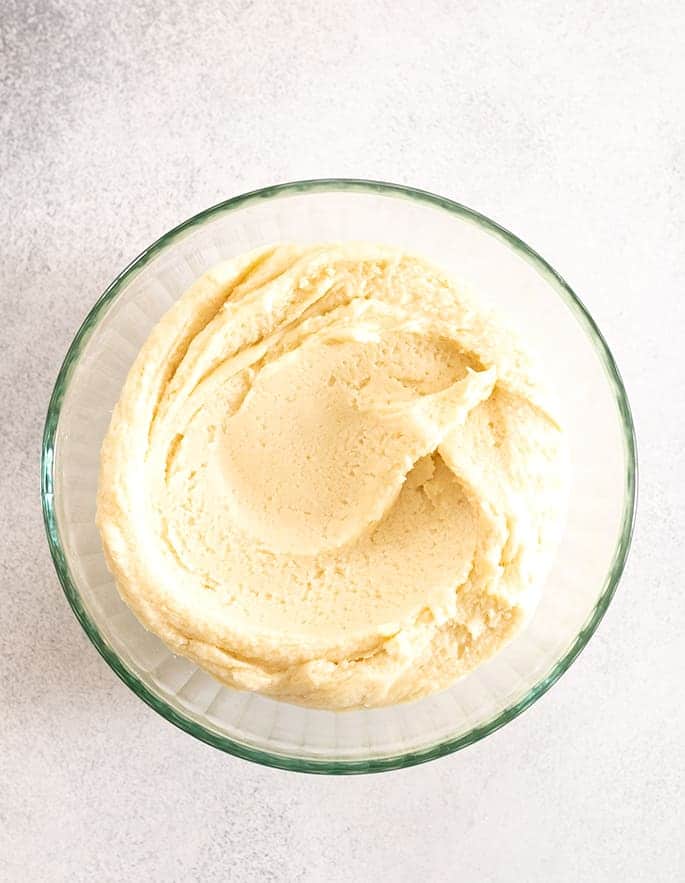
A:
[97, 243, 566, 709]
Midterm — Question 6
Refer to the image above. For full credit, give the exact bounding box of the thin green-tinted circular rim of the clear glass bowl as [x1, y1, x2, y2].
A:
[41, 178, 637, 774]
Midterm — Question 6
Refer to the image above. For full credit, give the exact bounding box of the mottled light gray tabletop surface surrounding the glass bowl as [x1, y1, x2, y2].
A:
[0, 0, 685, 883]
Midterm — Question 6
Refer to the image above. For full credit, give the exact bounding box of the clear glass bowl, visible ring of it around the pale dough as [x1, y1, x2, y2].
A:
[42, 180, 636, 773]
